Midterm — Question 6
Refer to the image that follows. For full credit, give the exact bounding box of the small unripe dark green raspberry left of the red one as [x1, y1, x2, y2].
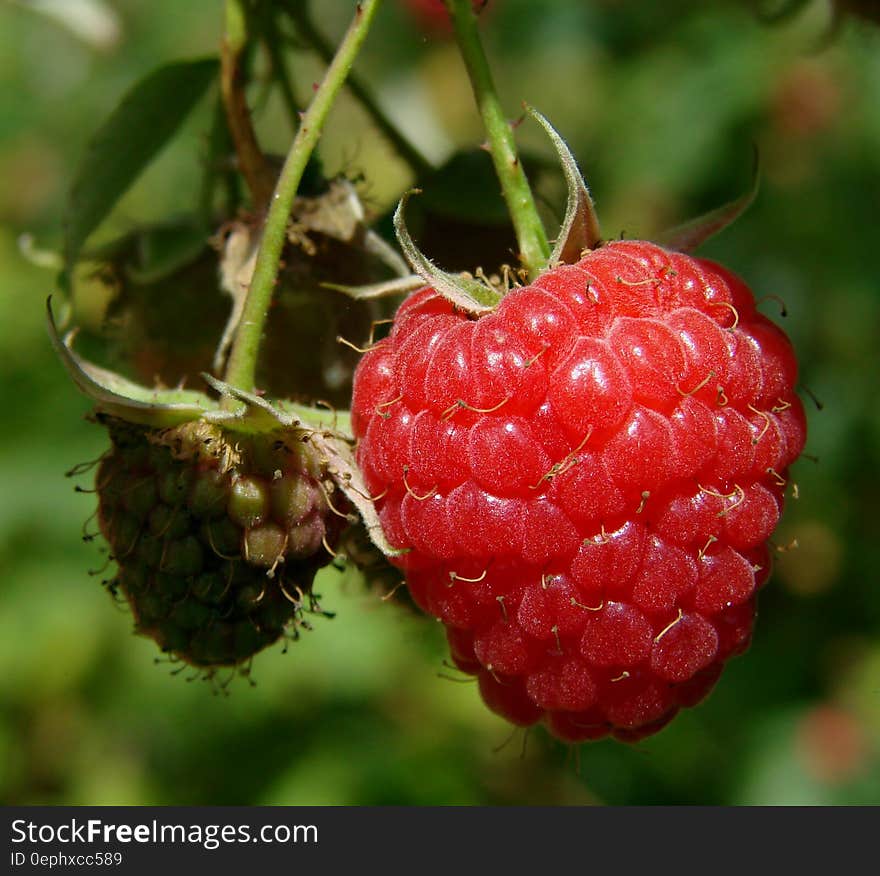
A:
[96, 417, 346, 670]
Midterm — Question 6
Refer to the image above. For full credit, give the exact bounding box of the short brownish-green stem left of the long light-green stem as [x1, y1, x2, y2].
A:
[220, 0, 273, 210]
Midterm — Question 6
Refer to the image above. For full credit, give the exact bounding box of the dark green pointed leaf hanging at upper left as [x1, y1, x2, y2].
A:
[64, 58, 218, 288]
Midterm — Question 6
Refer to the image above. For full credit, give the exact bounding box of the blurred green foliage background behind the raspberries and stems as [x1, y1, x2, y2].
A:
[0, 0, 880, 805]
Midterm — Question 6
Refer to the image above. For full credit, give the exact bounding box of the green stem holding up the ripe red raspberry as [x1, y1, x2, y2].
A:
[444, 0, 550, 279]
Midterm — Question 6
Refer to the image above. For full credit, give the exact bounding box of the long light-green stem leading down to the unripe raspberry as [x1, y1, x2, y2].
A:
[224, 0, 380, 407]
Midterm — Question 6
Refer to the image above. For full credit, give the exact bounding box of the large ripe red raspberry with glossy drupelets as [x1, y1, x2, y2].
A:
[353, 242, 805, 741]
